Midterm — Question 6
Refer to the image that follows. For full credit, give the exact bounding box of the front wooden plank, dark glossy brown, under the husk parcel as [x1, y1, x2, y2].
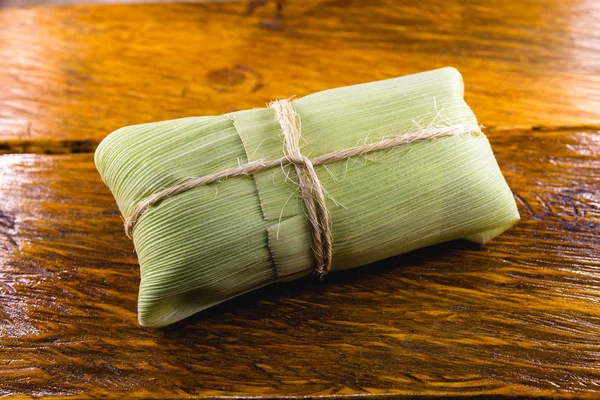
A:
[0, 130, 600, 398]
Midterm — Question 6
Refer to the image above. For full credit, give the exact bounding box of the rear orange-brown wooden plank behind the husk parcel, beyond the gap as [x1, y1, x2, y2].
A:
[0, 0, 600, 153]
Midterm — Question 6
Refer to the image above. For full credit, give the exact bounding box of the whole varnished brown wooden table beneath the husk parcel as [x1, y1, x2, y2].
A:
[0, 0, 600, 398]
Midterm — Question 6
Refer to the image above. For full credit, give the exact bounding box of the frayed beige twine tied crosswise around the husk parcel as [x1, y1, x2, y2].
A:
[125, 100, 481, 279]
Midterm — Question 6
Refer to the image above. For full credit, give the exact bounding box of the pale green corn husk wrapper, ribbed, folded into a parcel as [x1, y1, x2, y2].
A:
[95, 68, 519, 327]
